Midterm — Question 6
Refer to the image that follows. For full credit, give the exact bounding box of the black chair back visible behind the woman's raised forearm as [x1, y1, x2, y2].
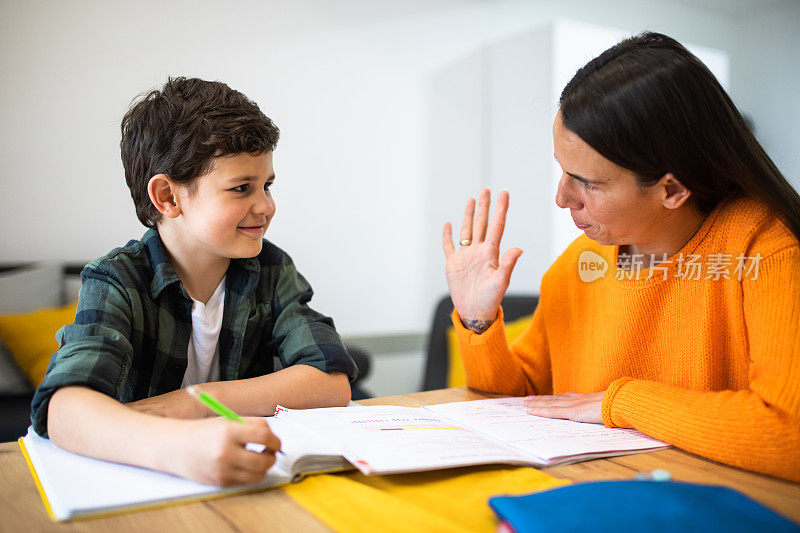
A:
[422, 295, 539, 390]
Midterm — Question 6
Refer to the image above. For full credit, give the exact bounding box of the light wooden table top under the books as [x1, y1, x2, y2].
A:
[0, 388, 800, 533]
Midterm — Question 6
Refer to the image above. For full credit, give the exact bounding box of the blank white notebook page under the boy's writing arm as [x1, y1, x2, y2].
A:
[22, 428, 292, 520]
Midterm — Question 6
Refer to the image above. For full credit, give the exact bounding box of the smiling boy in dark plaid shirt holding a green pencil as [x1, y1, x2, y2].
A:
[31, 78, 356, 485]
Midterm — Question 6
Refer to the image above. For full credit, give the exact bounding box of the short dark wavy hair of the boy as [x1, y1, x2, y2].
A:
[120, 77, 279, 228]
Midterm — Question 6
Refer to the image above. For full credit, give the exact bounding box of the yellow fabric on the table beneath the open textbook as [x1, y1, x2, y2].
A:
[283, 466, 570, 533]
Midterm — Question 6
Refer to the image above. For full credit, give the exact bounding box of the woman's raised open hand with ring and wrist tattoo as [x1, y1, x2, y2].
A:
[442, 189, 522, 333]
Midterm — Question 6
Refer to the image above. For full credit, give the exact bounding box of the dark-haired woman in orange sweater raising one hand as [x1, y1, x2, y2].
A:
[444, 33, 800, 481]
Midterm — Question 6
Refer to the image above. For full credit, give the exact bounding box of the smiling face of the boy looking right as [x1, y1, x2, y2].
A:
[177, 152, 275, 259]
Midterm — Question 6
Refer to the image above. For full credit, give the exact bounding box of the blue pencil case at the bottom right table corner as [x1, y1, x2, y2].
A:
[489, 480, 800, 533]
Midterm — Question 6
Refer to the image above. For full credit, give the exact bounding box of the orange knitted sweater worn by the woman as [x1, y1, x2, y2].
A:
[454, 199, 800, 481]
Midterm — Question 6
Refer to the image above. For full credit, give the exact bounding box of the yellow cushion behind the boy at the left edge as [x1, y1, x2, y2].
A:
[0, 301, 78, 387]
